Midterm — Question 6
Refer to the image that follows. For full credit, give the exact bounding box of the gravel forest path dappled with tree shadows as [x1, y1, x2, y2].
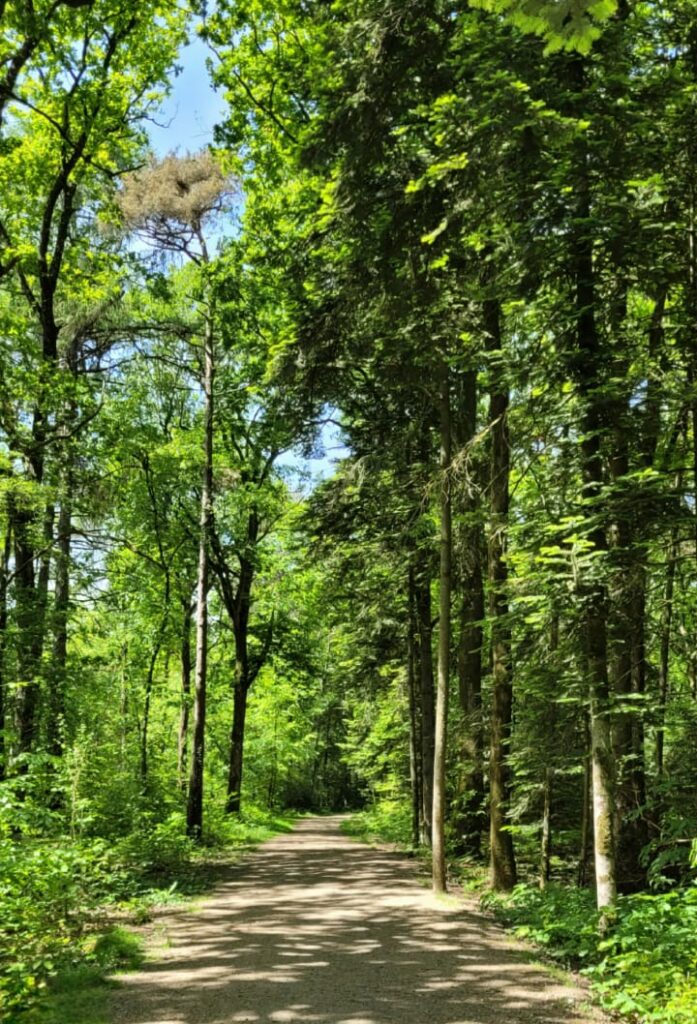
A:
[108, 817, 601, 1024]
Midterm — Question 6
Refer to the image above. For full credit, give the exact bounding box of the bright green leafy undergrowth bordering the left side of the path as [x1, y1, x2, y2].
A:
[0, 808, 293, 1024]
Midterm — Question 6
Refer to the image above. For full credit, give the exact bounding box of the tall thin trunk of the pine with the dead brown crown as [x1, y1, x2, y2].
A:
[186, 310, 215, 841]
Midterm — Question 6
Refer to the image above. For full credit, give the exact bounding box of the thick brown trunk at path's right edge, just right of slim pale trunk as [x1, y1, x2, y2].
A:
[484, 298, 516, 891]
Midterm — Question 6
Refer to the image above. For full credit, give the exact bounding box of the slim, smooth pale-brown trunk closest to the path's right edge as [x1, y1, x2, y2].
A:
[432, 358, 452, 893]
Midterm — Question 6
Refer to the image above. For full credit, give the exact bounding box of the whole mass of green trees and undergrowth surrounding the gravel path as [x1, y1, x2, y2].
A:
[0, 0, 697, 1022]
